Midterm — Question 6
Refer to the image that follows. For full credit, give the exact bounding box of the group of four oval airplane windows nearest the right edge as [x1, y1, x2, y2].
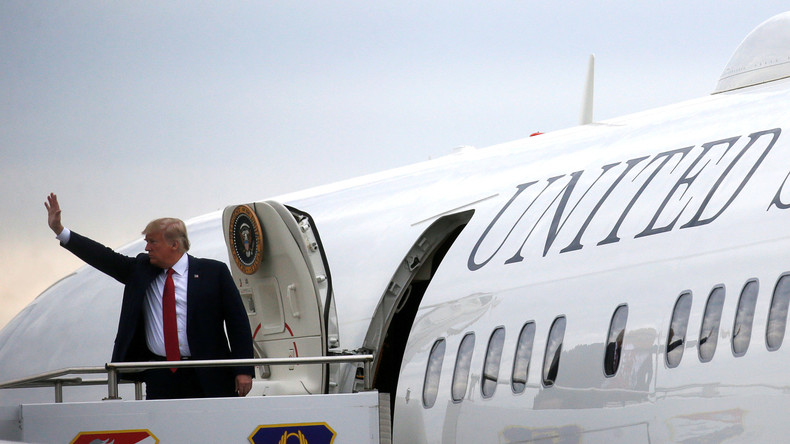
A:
[665, 273, 790, 368]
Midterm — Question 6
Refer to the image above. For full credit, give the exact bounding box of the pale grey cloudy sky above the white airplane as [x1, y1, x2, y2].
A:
[0, 0, 790, 326]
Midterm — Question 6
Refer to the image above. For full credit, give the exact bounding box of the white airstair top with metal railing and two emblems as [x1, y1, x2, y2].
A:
[0, 355, 391, 444]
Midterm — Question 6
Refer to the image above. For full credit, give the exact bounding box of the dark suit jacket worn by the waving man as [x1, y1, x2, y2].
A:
[63, 231, 255, 396]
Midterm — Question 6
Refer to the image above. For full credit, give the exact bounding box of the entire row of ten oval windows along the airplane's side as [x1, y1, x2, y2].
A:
[422, 273, 790, 408]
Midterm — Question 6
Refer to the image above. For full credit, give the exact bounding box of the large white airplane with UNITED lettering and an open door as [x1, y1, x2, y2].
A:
[0, 9, 790, 443]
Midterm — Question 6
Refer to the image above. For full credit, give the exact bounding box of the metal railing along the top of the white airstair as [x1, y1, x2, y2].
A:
[0, 355, 373, 403]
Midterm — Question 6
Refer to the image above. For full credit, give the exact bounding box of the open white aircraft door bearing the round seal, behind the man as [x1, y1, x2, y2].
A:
[222, 201, 339, 395]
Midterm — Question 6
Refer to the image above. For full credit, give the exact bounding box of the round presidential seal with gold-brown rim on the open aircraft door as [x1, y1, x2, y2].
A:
[228, 205, 263, 274]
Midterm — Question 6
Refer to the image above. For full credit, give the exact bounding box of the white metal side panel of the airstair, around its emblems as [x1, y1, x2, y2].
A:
[22, 392, 379, 444]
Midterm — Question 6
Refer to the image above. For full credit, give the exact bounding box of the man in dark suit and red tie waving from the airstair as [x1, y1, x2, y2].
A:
[44, 193, 254, 399]
